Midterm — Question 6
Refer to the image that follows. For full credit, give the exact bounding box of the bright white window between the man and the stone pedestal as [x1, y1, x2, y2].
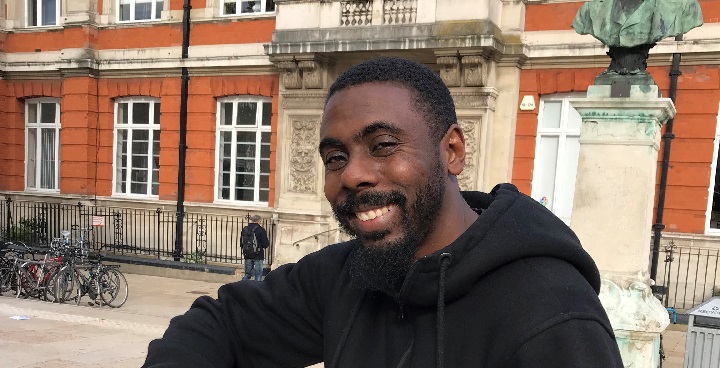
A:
[532, 94, 582, 224]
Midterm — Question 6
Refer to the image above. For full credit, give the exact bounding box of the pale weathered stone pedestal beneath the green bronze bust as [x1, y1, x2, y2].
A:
[571, 85, 675, 368]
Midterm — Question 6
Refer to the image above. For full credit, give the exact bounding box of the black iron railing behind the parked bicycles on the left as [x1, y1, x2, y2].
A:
[0, 197, 275, 265]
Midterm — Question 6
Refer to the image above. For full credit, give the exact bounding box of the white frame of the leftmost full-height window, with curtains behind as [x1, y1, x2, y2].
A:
[23, 98, 60, 192]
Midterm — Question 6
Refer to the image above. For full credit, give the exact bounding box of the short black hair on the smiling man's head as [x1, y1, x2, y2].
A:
[325, 57, 457, 141]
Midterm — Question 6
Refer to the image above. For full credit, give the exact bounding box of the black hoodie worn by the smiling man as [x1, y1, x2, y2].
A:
[144, 184, 622, 368]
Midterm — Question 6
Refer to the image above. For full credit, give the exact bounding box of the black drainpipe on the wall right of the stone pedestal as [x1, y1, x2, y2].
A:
[650, 35, 682, 281]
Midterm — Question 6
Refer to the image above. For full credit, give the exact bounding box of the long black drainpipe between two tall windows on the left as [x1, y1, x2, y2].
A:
[173, 0, 192, 261]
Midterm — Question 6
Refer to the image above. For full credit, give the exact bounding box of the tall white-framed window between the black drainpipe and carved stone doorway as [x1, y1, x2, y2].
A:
[216, 97, 272, 205]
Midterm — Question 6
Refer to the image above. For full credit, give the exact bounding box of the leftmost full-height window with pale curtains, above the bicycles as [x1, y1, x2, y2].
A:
[25, 99, 60, 190]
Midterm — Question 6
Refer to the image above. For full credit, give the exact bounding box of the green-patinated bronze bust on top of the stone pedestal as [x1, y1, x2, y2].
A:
[572, 0, 703, 84]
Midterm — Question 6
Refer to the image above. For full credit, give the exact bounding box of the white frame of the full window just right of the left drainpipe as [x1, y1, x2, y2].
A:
[213, 96, 272, 207]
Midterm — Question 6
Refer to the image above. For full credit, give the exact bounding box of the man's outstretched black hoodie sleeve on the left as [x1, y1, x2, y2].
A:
[143, 243, 343, 368]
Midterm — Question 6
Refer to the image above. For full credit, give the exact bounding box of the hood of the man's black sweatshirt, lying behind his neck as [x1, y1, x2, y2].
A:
[399, 184, 600, 306]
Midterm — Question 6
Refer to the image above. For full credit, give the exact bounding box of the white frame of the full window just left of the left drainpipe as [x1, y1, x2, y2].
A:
[112, 97, 160, 198]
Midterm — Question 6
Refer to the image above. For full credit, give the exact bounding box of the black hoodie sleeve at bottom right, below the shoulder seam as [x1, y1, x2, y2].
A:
[505, 319, 623, 368]
